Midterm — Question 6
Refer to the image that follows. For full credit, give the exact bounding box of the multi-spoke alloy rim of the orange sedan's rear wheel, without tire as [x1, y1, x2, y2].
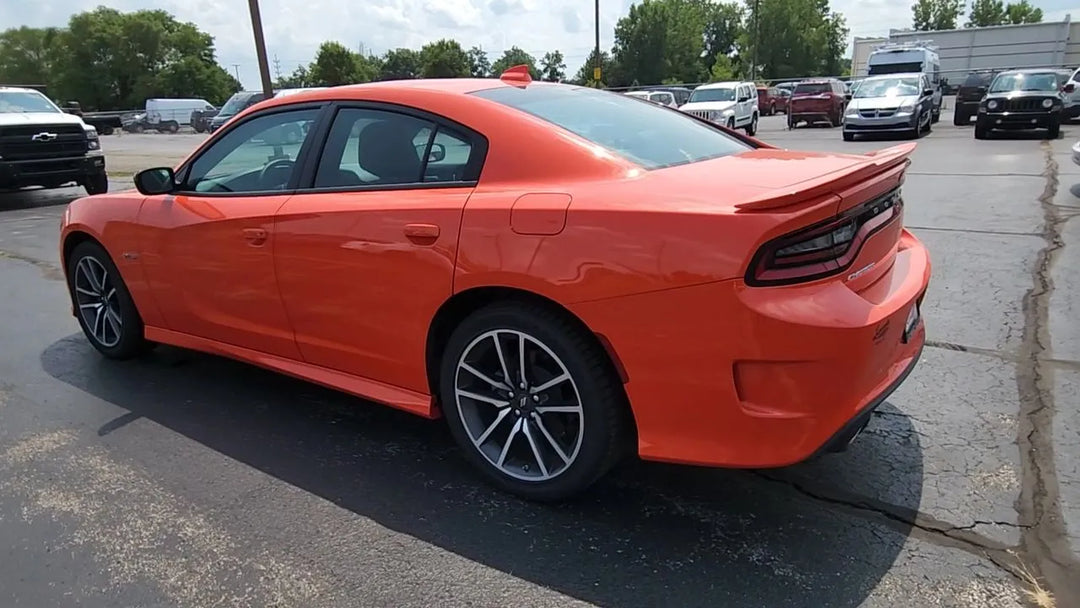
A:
[454, 329, 584, 482]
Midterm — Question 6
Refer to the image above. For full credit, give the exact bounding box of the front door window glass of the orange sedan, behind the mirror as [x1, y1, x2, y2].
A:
[181, 108, 319, 193]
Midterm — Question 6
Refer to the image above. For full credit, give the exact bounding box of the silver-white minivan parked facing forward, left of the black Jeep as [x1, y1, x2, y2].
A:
[843, 72, 934, 141]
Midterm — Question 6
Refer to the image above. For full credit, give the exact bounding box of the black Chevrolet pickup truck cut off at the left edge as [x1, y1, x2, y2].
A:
[0, 86, 109, 194]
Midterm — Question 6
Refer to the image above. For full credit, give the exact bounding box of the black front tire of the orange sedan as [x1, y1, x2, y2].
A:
[67, 241, 153, 360]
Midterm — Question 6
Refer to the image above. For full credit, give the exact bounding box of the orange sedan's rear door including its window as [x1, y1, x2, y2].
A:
[274, 105, 486, 393]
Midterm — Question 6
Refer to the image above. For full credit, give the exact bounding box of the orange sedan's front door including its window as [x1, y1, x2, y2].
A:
[138, 105, 320, 359]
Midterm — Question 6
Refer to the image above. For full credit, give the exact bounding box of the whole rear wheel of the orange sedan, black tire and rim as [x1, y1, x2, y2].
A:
[440, 302, 629, 501]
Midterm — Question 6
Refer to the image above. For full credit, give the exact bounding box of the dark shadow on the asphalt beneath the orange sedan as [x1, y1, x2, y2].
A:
[41, 335, 922, 608]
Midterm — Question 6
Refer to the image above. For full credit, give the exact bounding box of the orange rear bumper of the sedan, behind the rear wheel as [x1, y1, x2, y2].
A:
[571, 231, 930, 468]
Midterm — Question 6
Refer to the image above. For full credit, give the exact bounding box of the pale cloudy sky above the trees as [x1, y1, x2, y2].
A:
[0, 0, 1080, 89]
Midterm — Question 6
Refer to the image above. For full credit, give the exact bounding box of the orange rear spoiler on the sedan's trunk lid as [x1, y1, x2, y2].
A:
[735, 141, 917, 212]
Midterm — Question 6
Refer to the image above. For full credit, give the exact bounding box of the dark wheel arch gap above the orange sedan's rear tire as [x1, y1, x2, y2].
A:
[424, 286, 636, 419]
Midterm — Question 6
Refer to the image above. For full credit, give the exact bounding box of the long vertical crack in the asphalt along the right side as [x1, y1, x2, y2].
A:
[1016, 141, 1080, 606]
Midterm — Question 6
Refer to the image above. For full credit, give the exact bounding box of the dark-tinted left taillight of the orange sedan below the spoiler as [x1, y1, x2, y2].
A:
[746, 189, 903, 286]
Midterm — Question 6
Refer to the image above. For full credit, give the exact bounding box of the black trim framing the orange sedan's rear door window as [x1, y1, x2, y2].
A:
[296, 99, 488, 194]
